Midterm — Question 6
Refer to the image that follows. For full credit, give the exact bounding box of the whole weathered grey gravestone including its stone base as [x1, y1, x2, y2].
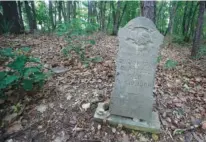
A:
[94, 17, 163, 133]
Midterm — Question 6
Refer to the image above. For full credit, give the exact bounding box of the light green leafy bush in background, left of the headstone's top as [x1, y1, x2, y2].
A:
[56, 19, 98, 36]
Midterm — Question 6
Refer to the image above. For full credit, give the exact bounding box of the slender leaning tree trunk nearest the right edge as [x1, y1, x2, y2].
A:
[191, 1, 205, 57]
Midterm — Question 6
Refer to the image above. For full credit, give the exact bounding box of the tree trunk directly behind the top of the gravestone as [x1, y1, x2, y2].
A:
[141, 1, 155, 23]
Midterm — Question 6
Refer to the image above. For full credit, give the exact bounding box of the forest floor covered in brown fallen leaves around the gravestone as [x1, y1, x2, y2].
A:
[0, 33, 206, 142]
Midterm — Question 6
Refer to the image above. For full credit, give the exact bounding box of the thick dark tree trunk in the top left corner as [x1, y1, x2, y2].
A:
[1, 1, 21, 34]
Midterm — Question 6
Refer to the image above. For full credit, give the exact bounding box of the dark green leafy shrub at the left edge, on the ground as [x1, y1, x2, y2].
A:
[0, 47, 49, 97]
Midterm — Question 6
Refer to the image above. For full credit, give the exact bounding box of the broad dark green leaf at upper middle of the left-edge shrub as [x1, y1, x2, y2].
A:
[8, 56, 26, 71]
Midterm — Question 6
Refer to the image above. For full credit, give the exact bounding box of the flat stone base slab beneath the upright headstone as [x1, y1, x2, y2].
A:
[94, 103, 160, 133]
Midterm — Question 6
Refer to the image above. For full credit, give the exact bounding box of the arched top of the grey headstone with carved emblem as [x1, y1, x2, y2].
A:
[118, 17, 164, 47]
